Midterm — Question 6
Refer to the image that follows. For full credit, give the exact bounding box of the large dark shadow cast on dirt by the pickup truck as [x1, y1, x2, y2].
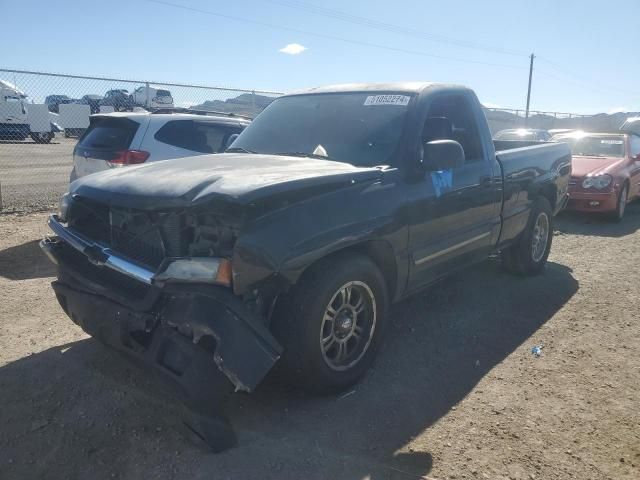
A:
[0, 260, 578, 479]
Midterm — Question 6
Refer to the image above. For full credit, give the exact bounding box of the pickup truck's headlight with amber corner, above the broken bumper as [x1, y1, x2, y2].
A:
[153, 258, 232, 287]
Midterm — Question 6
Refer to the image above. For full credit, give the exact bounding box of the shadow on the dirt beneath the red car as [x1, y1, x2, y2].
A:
[555, 201, 640, 237]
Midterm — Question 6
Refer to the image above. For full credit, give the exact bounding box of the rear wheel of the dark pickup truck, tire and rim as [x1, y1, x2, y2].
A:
[502, 197, 553, 275]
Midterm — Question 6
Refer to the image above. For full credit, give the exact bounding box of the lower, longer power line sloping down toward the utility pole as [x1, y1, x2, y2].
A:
[145, 0, 522, 69]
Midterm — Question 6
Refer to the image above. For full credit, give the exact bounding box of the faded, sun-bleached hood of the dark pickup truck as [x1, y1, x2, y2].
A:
[70, 153, 381, 209]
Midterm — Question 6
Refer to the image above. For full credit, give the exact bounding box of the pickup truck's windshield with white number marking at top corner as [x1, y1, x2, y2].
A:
[231, 93, 410, 166]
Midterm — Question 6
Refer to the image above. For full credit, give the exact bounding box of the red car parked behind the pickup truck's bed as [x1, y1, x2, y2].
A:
[551, 132, 640, 221]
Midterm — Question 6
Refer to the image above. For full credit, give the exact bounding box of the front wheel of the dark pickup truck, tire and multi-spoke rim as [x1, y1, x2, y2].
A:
[273, 253, 388, 393]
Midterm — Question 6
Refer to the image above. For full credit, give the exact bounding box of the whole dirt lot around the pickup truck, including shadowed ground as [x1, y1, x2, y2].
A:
[0, 208, 640, 479]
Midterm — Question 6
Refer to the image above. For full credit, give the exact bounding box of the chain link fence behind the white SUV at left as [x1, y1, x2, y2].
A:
[0, 69, 280, 212]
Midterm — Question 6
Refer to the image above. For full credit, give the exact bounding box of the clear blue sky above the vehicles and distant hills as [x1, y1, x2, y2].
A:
[0, 0, 640, 113]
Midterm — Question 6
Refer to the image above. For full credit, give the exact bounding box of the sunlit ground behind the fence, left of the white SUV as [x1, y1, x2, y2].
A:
[0, 134, 78, 212]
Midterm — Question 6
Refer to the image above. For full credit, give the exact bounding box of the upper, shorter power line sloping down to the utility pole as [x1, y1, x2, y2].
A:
[269, 0, 527, 57]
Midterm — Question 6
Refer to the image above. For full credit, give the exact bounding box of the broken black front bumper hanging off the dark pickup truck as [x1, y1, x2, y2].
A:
[41, 234, 281, 452]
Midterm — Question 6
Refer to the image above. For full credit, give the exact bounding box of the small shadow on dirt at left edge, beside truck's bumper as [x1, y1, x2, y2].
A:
[0, 240, 56, 280]
